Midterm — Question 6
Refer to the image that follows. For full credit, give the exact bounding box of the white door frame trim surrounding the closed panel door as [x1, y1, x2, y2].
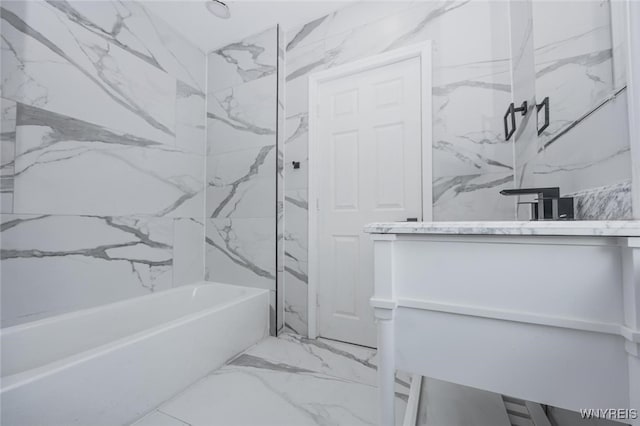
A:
[307, 41, 433, 339]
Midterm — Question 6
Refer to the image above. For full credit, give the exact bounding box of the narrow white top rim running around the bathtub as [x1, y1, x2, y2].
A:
[0, 281, 269, 395]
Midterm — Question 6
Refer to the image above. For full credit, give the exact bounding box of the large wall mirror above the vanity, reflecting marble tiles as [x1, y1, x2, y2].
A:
[510, 0, 632, 220]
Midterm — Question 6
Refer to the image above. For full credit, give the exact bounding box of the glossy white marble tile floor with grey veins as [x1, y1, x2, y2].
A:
[132, 334, 410, 426]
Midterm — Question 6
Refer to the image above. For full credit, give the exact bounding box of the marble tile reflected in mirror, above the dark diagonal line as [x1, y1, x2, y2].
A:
[533, 1, 614, 146]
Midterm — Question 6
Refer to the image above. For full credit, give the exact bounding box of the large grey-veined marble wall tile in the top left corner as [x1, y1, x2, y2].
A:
[2, 2, 176, 144]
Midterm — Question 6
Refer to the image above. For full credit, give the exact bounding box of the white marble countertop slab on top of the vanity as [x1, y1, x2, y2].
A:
[364, 220, 640, 237]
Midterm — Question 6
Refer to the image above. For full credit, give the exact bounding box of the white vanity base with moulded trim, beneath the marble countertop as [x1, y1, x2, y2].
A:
[367, 222, 640, 425]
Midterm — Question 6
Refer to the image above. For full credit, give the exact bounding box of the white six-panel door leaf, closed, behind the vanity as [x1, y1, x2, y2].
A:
[316, 57, 422, 347]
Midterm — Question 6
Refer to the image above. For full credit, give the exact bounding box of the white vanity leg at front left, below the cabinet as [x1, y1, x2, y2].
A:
[376, 309, 396, 426]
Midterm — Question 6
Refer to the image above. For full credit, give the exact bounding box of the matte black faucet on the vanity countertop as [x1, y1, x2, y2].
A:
[500, 187, 573, 220]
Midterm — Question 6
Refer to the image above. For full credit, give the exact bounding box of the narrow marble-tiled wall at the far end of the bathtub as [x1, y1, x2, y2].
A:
[205, 27, 276, 334]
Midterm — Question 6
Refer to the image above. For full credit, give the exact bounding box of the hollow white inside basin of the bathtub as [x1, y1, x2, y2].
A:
[0, 282, 264, 378]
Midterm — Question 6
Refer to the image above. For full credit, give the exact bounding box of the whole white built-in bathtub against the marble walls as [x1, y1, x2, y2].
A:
[0, 282, 269, 426]
